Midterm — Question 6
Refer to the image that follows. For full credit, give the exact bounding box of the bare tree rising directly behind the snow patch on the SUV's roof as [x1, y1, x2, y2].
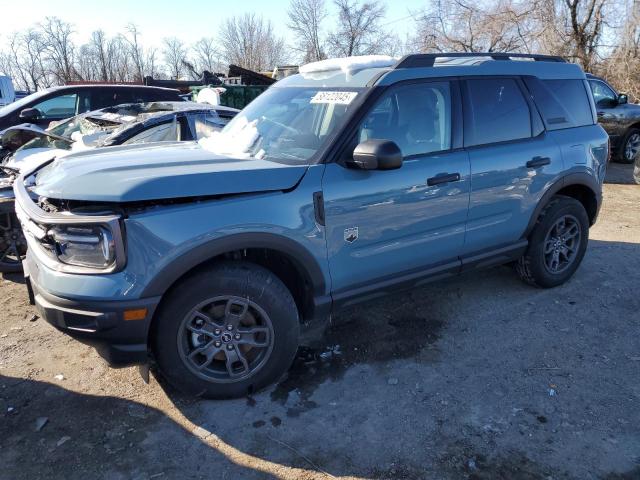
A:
[328, 0, 388, 57]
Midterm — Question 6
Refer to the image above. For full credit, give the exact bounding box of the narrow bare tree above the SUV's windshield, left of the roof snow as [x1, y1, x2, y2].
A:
[287, 0, 327, 63]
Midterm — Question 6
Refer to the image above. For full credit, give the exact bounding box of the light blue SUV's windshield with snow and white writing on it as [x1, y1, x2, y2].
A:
[199, 87, 363, 163]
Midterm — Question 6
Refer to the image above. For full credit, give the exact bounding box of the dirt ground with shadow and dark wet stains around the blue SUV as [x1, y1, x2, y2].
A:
[0, 164, 640, 480]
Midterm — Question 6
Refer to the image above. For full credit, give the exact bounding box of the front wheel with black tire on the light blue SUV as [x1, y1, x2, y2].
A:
[151, 261, 300, 399]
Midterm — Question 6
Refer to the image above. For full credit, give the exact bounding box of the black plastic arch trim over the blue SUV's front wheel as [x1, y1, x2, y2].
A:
[141, 232, 328, 297]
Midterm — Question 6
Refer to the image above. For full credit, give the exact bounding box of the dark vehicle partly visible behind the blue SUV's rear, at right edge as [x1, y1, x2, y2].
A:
[587, 73, 640, 163]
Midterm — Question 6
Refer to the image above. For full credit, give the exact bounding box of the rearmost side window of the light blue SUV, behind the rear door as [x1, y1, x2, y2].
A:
[525, 78, 595, 130]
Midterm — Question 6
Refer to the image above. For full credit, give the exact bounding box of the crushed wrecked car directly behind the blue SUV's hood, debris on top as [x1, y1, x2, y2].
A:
[0, 102, 238, 272]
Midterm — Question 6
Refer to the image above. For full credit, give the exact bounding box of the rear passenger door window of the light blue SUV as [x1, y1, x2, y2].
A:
[464, 78, 531, 146]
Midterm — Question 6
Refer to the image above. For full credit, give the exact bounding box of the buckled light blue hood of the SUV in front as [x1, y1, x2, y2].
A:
[33, 142, 307, 202]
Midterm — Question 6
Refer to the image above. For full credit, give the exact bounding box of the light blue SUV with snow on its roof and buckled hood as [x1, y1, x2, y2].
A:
[14, 54, 609, 398]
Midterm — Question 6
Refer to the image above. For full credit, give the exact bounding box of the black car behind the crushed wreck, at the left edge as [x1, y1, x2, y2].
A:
[0, 85, 183, 130]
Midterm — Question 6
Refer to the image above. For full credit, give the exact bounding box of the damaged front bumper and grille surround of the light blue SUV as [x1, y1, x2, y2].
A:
[14, 177, 160, 367]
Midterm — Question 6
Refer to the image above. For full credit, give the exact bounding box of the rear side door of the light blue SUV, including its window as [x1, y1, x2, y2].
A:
[462, 77, 563, 255]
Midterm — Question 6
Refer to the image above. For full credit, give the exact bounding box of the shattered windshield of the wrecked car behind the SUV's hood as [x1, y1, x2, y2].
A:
[18, 116, 121, 150]
